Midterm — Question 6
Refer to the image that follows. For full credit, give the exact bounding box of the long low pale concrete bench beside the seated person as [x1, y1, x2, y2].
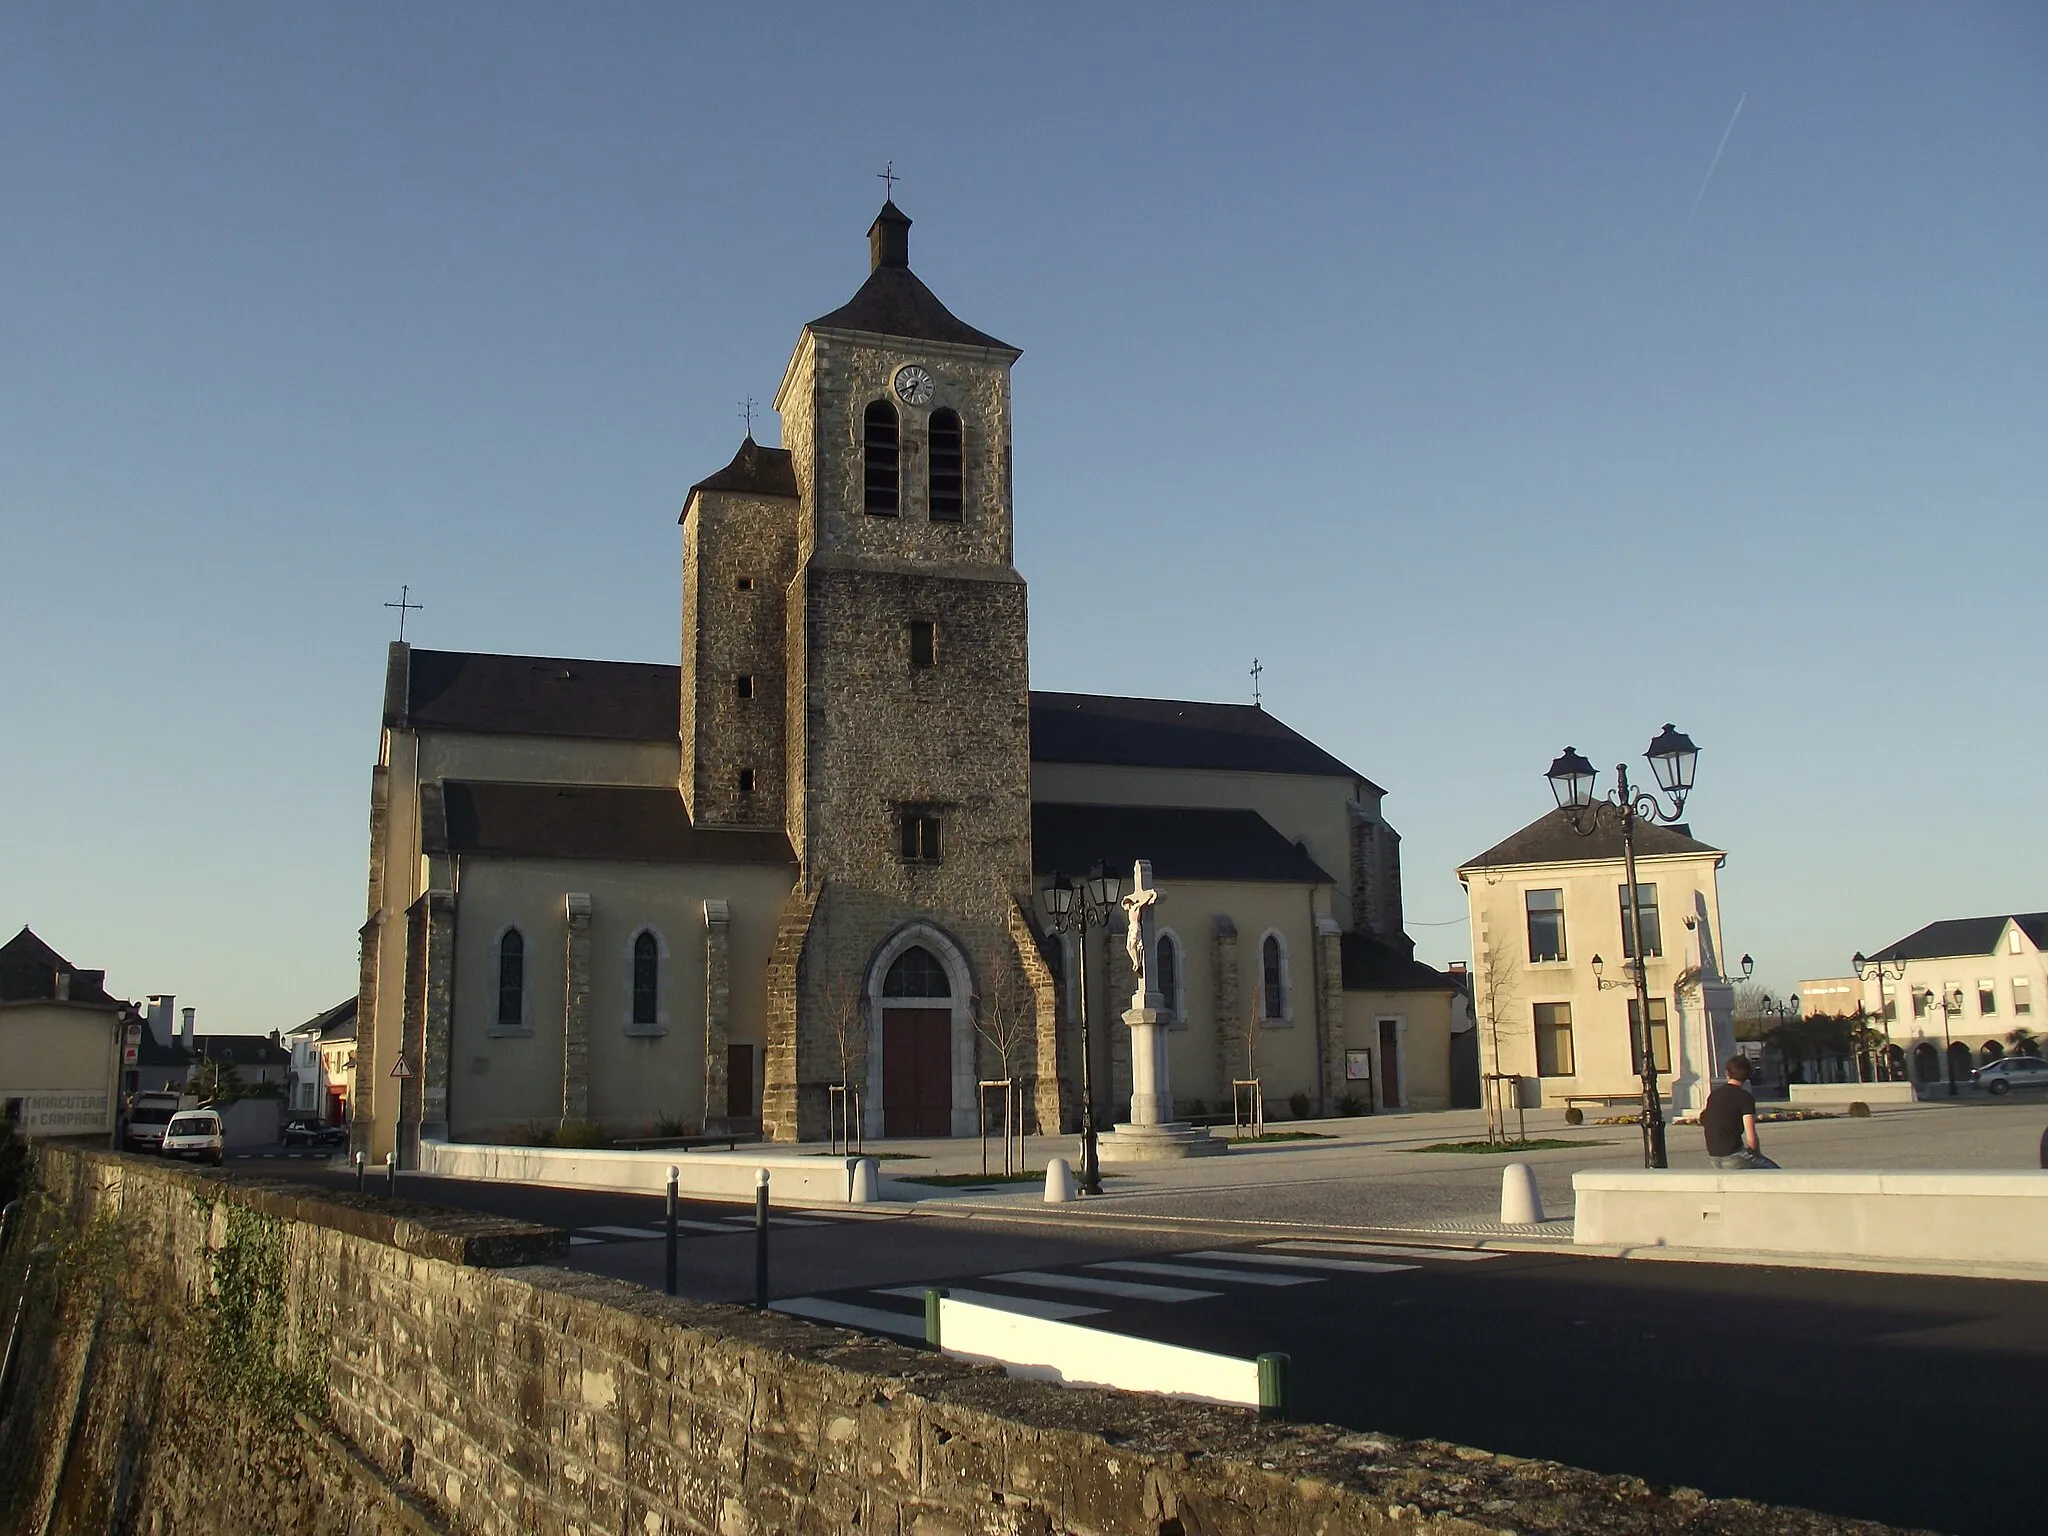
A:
[1571, 1169, 2048, 1268]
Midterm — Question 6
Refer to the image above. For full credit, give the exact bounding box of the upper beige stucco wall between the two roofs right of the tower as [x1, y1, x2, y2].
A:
[1030, 762, 1380, 928]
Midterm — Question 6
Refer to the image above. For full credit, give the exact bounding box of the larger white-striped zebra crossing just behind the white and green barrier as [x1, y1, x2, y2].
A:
[770, 1239, 1501, 1339]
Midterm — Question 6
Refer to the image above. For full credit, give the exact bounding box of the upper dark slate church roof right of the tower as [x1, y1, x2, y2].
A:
[1030, 692, 1378, 793]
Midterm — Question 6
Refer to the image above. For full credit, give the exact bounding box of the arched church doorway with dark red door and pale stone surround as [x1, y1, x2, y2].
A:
[864, 924, 975, 1137]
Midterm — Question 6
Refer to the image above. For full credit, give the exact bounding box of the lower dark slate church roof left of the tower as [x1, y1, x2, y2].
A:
[420, 780, 797, 864]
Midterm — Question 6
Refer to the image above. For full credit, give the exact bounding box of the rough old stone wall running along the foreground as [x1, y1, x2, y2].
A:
[0, 1147, 1916, 1536]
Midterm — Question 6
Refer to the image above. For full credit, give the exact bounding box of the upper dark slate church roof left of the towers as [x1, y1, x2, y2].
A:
[385, 651, 682, 741]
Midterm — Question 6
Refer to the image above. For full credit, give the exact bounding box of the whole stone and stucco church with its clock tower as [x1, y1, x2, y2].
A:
[354, 201, 1479, 1165]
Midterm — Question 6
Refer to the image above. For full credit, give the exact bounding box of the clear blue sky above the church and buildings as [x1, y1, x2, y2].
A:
[0, 0, 2048, 1030]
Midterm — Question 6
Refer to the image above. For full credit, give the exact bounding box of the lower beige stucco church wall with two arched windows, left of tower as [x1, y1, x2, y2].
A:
[451, 858, 791, 1139]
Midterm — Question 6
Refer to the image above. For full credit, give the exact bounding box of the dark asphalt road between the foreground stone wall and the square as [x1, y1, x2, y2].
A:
[231, 1163, 2048, 1536]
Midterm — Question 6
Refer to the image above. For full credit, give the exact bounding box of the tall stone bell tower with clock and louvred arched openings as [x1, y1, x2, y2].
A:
[764, 203, 1057, 1137]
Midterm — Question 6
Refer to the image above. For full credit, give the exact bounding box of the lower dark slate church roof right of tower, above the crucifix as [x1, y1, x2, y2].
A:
[1030, 805, 1331, 885]
